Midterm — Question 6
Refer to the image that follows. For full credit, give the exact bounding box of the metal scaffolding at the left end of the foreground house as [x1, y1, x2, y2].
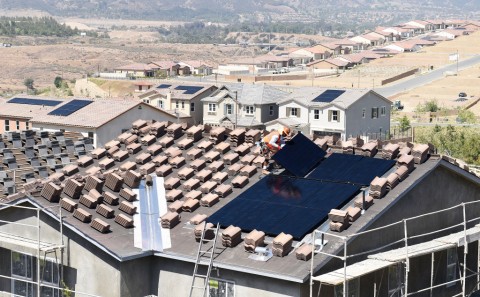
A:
[0, 203, 97, 297]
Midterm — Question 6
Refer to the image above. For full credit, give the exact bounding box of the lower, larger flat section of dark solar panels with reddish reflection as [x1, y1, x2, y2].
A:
[207, 175, 360, 240]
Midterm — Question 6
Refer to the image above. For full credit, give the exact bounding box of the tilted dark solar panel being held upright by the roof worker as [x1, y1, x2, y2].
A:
[273, 133, 325, 177]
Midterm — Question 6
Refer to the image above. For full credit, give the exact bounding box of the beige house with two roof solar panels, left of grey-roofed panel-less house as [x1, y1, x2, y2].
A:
[138, 82, 217, 124]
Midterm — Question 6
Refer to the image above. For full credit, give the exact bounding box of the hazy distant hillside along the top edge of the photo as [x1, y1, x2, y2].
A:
[0, 0, 480, 22]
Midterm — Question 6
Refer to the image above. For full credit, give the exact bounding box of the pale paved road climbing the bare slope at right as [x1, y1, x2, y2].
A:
[375, 55, 480, 98]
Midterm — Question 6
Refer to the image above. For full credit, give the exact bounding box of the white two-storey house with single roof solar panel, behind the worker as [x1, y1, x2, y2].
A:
[266, 87, 391, 140]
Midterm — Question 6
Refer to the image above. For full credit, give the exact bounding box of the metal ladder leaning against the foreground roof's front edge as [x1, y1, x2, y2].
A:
[189, 222, 220, 297]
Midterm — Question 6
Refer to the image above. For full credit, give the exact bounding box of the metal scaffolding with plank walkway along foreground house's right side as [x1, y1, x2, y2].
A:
[309, 201, 480, 297]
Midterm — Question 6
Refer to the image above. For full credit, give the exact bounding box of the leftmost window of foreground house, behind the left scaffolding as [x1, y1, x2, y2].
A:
[12, 251, 35, 297]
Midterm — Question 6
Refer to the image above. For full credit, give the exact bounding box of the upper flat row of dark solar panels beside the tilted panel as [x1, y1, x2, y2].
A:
[308, 154, 395, 185]
